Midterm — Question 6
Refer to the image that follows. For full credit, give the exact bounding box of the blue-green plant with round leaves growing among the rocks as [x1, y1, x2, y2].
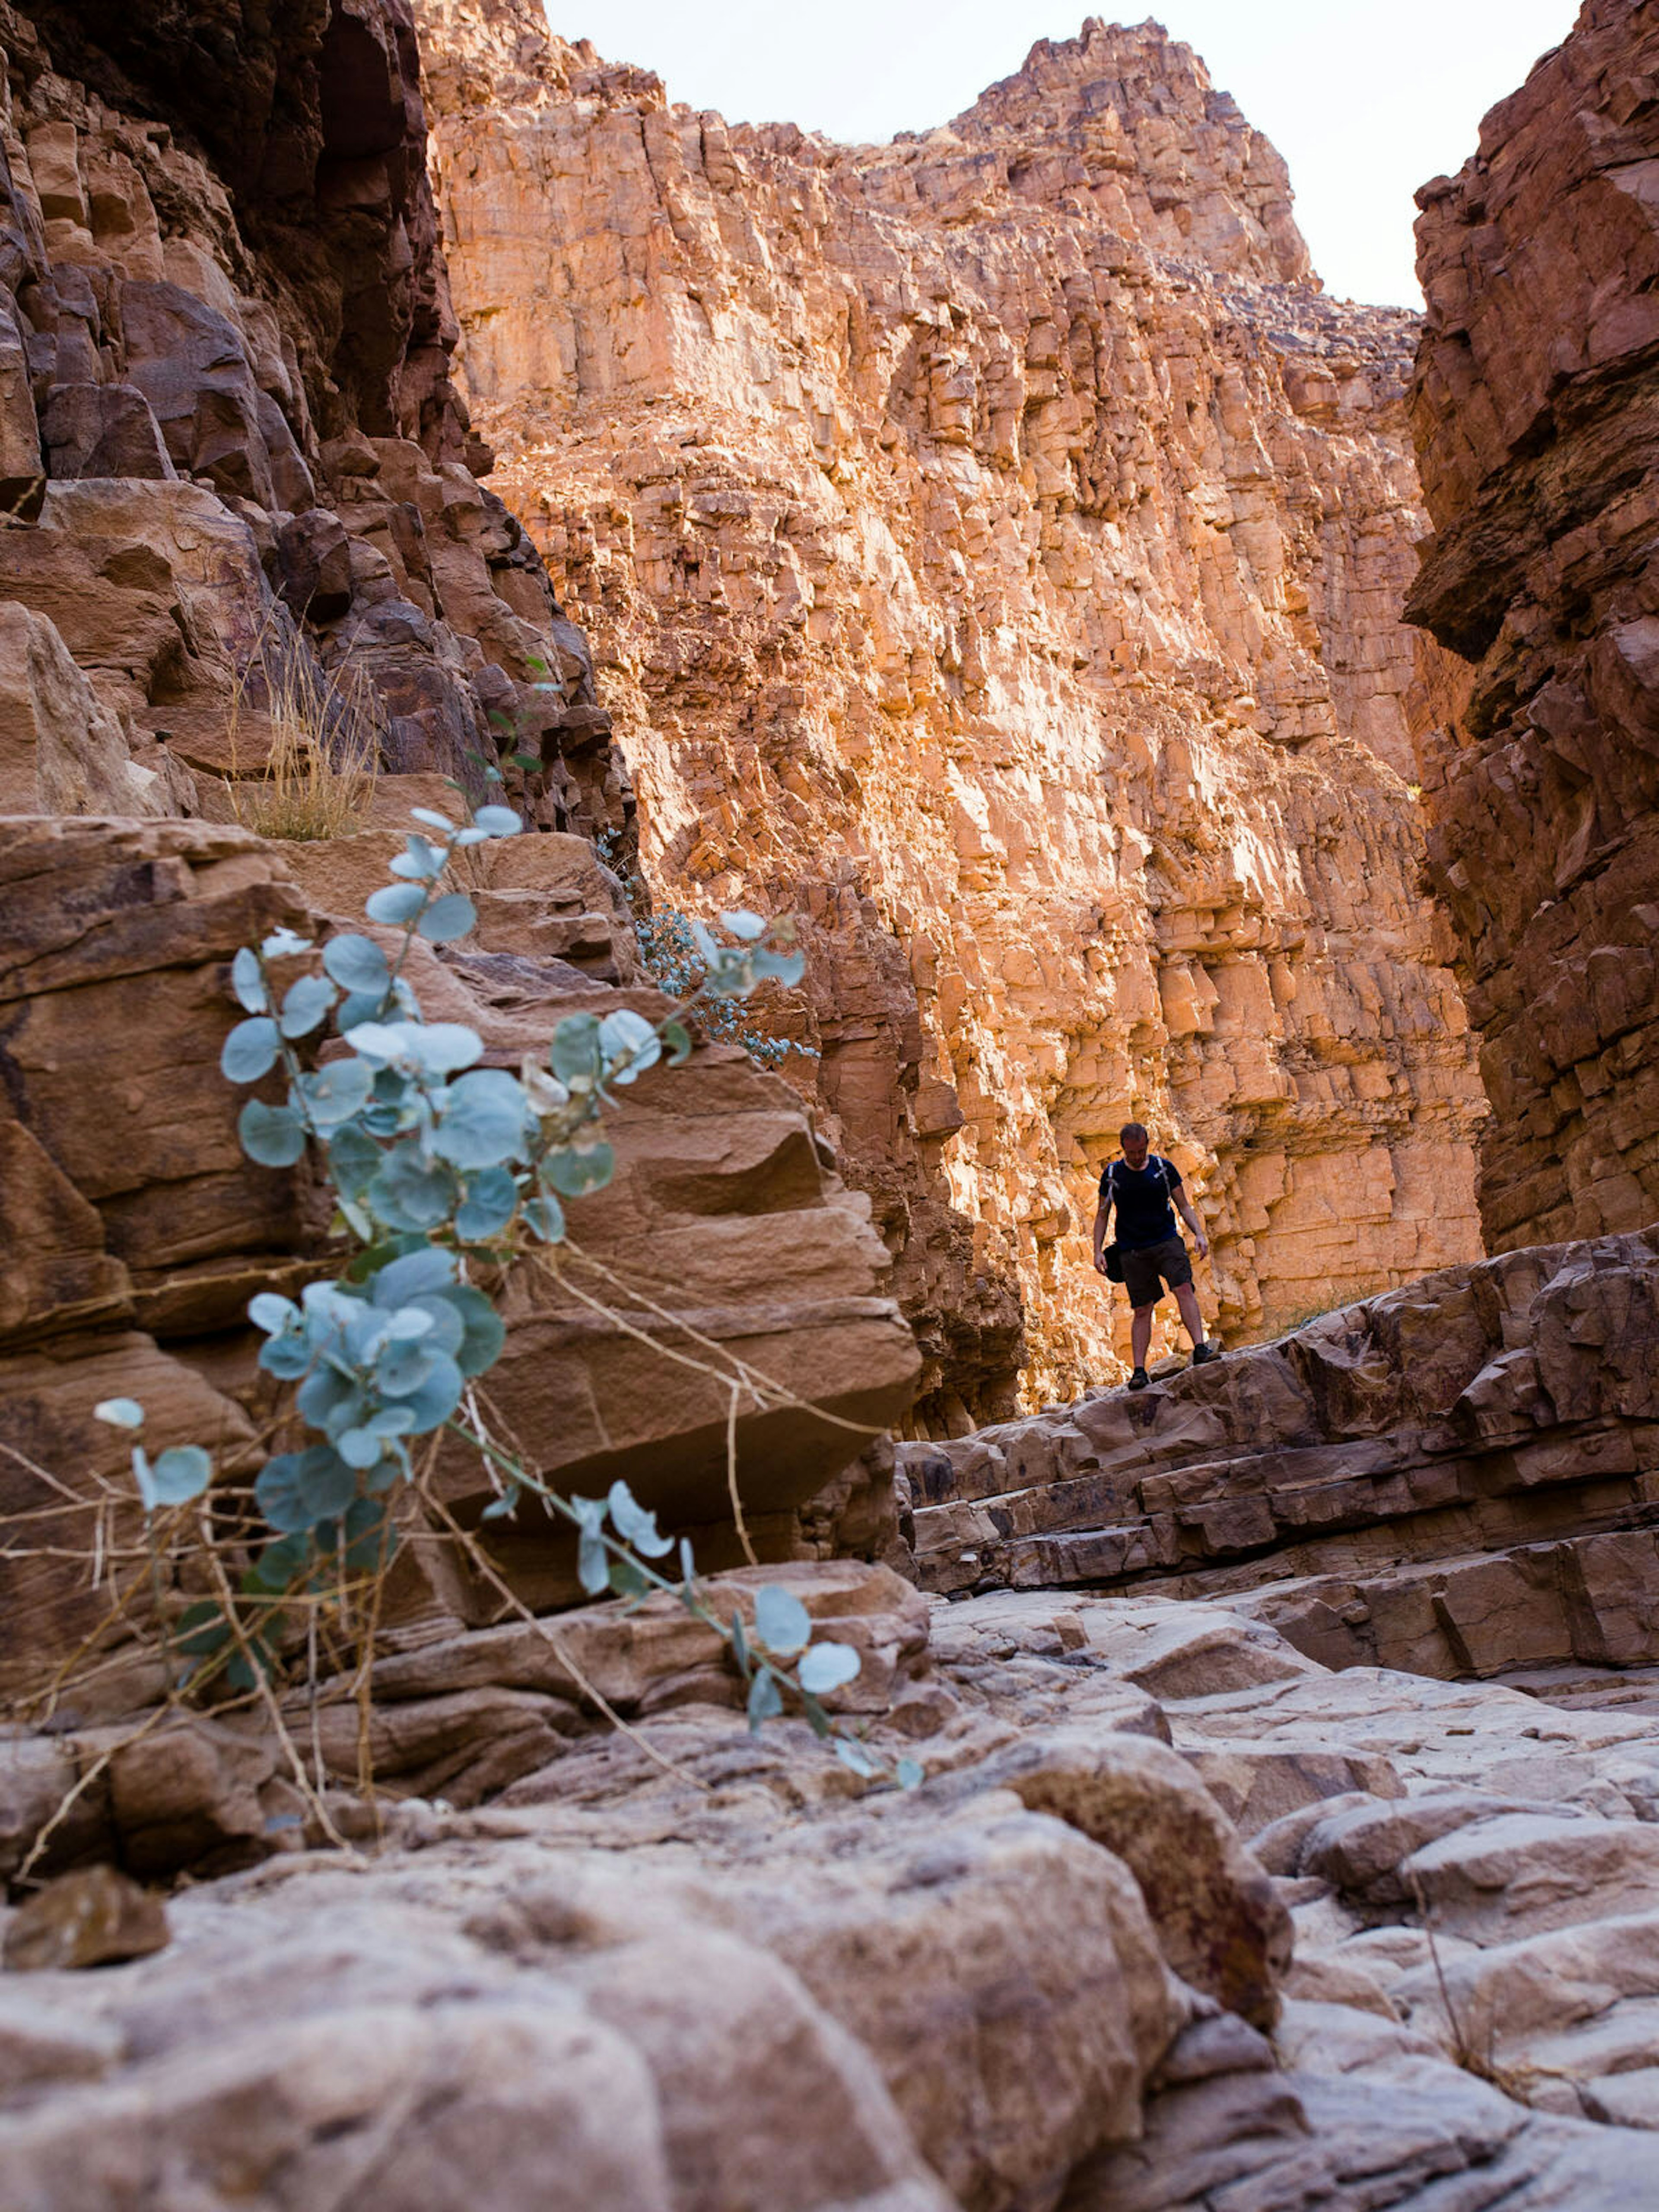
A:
[97, 805, 920, 1781]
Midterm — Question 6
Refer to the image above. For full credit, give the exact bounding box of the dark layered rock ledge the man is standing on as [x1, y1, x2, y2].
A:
[900, 1230, 1659, 1677]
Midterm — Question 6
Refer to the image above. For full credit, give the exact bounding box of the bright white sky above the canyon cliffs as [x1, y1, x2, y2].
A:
[549, 0, 1577, 308]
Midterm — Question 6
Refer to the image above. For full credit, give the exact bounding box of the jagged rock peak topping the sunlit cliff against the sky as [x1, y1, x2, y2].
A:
[951, 16, 1316, 283]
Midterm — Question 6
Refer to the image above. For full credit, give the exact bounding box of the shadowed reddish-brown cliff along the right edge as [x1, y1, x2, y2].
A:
[1409, 0, 1659, 1250]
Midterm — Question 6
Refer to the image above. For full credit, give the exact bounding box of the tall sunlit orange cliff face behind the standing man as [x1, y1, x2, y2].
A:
[418, 0, 1482, 1427]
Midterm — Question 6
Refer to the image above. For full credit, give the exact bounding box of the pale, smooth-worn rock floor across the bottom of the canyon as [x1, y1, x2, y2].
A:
[0, 1568, 1659, 2212]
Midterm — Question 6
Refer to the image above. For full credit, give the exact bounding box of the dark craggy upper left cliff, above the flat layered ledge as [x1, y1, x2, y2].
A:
[0, 0, 630, 845]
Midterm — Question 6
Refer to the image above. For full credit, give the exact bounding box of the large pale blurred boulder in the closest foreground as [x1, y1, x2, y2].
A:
[0, 1787, 1183, 2212]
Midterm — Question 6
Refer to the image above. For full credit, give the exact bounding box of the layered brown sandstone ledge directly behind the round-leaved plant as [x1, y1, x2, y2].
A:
[0, 818, 918, 1710]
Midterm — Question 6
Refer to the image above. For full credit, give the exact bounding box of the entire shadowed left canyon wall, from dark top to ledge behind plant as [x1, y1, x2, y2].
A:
[0, 0, 918, 1697]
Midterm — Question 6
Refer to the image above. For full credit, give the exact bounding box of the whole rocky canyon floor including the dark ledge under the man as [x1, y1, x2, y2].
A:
[0, 1234, 1659, 2212]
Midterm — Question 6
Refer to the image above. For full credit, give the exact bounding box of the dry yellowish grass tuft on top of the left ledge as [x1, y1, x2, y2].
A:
[230, 610, 385, 841]
